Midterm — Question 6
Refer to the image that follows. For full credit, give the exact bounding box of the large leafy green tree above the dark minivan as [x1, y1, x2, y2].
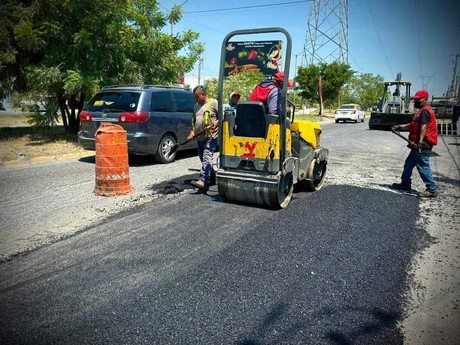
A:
[0, 0, 203, 133]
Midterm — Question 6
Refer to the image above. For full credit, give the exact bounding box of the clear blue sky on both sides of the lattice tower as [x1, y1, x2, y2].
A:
[160, 0, 460, 96]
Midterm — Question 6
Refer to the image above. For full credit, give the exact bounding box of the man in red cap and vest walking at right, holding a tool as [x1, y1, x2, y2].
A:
[392, 90, 438, 197]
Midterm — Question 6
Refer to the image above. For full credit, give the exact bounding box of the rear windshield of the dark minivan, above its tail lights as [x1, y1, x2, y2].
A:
[87, 91, 141, 111]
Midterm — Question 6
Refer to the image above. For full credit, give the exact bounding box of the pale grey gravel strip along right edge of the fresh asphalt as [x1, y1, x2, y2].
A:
[401, 136, 460, 345]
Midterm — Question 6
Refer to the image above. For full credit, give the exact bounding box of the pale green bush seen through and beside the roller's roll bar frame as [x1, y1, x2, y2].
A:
[204, 70, 264, 103]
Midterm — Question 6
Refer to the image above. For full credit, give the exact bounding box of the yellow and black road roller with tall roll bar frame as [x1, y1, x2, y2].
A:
[216, 28, 329, 208]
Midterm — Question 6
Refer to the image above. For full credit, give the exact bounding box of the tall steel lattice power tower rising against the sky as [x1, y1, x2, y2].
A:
[302, 0, 348, 65]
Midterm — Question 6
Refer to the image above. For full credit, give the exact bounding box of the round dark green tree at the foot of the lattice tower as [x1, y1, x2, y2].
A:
[296, 62, 354, 106]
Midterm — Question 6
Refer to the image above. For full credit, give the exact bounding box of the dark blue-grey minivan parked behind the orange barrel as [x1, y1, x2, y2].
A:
[78, 85, 196, 163]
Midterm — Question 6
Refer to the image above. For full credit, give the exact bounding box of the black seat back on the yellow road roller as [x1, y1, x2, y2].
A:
[234, 101, 267, 138]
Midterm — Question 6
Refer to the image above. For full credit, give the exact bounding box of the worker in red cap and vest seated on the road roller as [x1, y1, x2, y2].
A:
[249, 71, 284, 115]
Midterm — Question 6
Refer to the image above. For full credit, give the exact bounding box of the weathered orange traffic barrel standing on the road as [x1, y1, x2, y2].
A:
[94, 123, 133, 196]
